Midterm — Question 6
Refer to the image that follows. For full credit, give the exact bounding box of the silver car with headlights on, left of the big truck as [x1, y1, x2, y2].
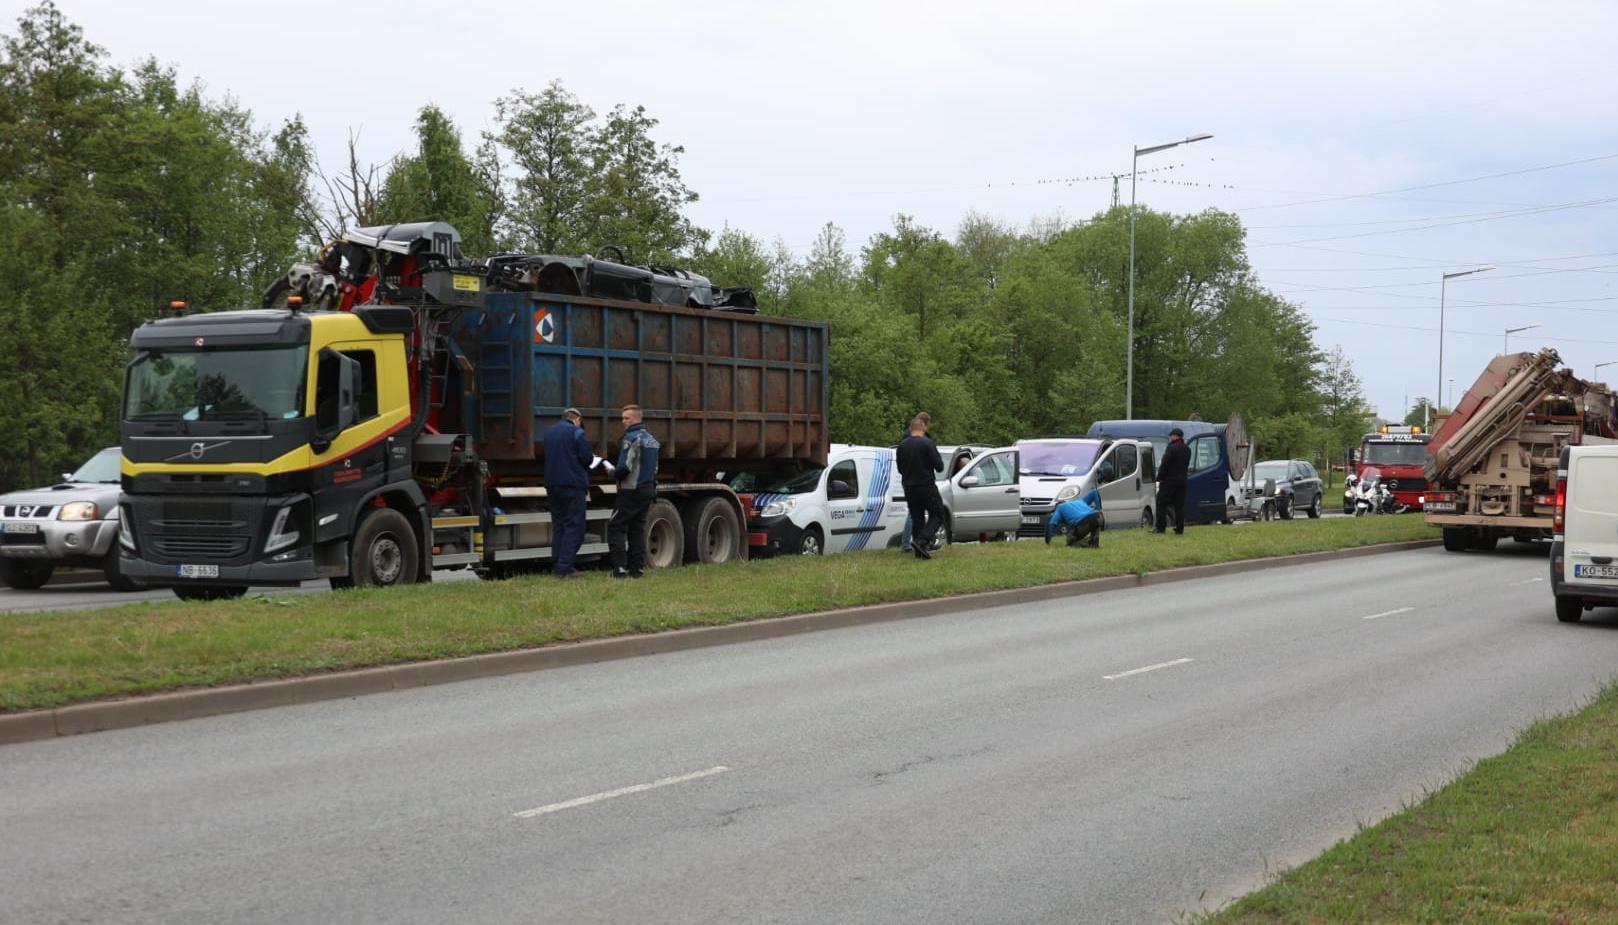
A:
[0, 446, 138, 590]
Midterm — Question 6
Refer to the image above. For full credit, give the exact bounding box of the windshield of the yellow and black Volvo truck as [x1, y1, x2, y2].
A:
[123, 344, 309, 420]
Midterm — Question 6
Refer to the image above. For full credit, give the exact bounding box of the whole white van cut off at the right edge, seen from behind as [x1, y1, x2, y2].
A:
[1550, 445, 1618, 623]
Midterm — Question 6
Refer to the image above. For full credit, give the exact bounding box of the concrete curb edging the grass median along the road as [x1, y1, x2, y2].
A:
[0, 540, 1440, 745]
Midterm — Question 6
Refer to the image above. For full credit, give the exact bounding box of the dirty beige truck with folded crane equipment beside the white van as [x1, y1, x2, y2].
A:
[1421, 348, 1618, 551]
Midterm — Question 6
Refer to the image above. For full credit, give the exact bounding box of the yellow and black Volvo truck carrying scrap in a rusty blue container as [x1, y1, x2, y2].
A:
[118, 223, 828, 600]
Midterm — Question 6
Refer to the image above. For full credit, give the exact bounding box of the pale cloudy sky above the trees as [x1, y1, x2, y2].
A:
[12, 0, 1618, 417]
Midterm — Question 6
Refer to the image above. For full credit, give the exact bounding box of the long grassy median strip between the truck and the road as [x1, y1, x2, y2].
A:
[0, 516, 1437, 712]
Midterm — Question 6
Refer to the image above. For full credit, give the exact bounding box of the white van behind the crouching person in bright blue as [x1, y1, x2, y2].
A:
[1016, 437, 1157, 539]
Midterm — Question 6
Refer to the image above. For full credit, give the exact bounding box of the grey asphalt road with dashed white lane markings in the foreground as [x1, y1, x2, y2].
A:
[0, 547, 1618, 923]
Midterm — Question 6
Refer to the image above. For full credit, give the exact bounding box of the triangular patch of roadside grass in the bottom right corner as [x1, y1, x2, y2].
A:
[1196, 687, 1618, 925]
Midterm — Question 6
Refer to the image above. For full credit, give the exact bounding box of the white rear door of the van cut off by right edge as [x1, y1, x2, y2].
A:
[1561, 446, 1618, 595]
